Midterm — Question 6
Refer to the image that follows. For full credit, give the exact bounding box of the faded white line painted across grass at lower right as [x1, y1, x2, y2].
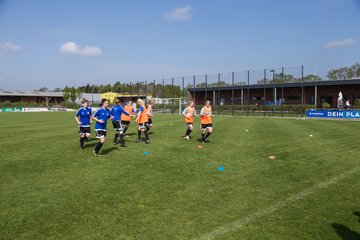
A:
[194, 168, 360, 240]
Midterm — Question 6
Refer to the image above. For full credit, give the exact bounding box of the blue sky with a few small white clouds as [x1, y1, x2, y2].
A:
[0, 0, 360, 90]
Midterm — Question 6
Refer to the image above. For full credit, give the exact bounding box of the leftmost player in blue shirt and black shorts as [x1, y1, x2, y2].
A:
[75, 99, 91, 149]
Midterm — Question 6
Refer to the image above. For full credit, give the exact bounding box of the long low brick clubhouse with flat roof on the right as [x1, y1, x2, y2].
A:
[188, 78, 360, 108]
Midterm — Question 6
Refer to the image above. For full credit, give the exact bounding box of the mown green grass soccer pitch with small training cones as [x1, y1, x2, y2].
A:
[0, 113, 360, 240]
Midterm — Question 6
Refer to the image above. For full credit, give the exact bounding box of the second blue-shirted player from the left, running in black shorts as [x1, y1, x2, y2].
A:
[92, 99, 112, 157]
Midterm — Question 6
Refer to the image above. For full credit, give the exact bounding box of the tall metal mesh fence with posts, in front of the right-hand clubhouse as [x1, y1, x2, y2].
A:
[112, 66, 330, 116]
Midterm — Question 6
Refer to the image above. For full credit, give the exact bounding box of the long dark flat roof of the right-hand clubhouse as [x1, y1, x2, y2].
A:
[189, 78, 360, 92]
